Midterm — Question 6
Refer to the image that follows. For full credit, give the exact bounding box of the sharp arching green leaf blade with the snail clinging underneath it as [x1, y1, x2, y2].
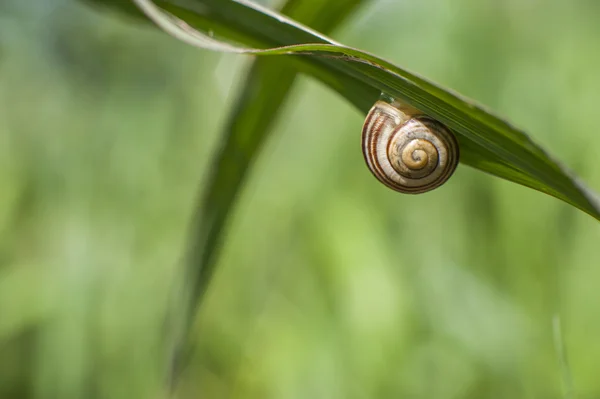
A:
[135, 0, 600, 220]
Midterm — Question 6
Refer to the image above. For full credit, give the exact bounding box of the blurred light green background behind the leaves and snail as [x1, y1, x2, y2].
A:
[0, 0, 600, 399]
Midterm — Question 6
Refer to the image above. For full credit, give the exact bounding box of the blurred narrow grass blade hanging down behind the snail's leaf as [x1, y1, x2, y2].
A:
[164, 0, 370, 384]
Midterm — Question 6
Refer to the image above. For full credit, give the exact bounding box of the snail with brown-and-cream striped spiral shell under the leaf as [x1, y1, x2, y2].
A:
[362, 101, 459, 194]
